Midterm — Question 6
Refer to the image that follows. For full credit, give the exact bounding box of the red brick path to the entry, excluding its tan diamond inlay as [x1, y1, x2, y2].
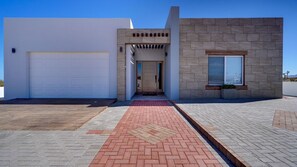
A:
[90, 101, 221, 167]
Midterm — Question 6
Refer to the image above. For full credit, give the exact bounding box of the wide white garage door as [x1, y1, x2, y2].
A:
[30, 52, 109, 98]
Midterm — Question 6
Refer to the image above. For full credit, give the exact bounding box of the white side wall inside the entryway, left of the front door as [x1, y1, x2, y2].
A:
[126, 45, 136, 100]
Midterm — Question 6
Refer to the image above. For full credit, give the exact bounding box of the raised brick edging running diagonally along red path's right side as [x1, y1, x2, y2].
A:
[171, 101, 251, 167]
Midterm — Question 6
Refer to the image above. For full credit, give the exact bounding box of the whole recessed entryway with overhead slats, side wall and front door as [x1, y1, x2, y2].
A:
[125, 44, 170, 100]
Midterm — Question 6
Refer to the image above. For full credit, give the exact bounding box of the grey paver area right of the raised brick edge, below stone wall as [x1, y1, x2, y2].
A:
[177, 97, 297, 167]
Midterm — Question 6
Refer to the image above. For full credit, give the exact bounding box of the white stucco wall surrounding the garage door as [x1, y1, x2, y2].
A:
[4, 18, 132, 99]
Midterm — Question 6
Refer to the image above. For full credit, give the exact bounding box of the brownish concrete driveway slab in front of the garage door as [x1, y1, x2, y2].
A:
[0, 99, 114, 130]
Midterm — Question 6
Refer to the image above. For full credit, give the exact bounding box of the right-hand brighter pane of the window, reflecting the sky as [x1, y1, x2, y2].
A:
[225, 56, 242, 85]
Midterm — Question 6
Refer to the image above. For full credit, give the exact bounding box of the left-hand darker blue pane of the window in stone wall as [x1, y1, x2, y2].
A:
[208, 57, 224, 85]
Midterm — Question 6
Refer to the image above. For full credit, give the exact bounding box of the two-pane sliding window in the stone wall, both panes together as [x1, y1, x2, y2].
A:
[208, 56, 243, 85]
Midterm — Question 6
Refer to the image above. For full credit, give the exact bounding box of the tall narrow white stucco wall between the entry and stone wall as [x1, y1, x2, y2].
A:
[165, 7, 179, 100]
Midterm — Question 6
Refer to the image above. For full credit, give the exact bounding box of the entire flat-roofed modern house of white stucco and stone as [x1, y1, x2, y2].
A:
[4, 7, 283, 100]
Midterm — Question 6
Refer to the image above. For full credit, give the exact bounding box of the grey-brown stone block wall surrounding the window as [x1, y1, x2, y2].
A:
[179, 18, 283, 99]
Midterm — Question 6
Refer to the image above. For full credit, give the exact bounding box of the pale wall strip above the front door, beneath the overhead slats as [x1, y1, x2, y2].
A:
[135, 48, 165, 61]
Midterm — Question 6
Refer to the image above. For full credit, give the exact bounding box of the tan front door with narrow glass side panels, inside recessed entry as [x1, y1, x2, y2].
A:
[136, 61, 164, 95]
